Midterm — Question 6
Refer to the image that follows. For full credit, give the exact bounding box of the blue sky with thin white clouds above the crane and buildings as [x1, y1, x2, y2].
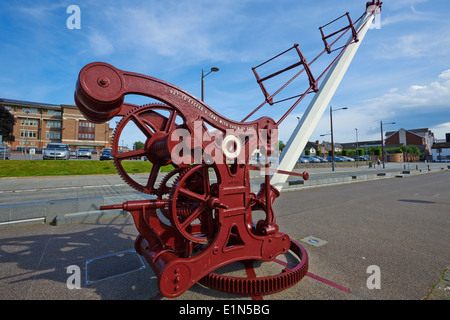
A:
[0, 0, 450, 146]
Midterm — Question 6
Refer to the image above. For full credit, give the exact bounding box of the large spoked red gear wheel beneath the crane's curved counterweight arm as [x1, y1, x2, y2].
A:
[112, 103, 184, 194]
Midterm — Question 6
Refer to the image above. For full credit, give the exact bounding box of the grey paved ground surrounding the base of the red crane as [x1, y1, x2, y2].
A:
[0, 166, 450, 301]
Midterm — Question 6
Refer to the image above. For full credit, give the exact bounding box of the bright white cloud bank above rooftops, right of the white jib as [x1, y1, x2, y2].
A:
[306, 69, 450, 142]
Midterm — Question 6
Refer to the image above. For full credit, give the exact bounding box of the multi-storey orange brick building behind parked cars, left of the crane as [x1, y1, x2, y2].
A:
[0, 98, 112, 151]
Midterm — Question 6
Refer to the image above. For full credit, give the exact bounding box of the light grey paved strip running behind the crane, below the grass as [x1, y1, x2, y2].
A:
[0, 163, 448, 227]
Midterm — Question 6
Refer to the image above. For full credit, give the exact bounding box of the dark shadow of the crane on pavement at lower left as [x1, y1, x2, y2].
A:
[0, 218, 158, 300]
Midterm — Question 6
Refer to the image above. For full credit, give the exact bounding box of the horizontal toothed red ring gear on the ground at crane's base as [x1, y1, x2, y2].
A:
[199, 240, 308, 296]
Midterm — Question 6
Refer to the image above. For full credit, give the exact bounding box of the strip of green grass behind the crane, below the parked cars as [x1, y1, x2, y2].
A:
[0, 160, 173, 177]
